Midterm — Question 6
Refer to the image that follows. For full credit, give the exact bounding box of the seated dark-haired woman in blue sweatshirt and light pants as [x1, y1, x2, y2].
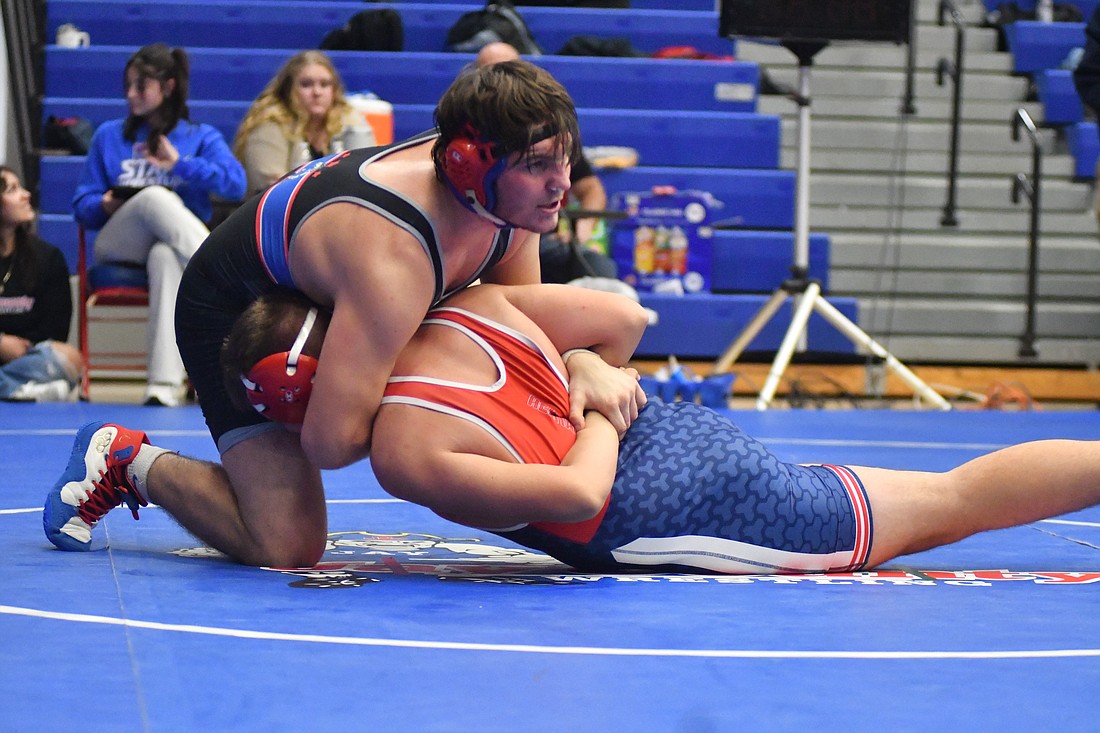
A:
[73, 43, 244, 406]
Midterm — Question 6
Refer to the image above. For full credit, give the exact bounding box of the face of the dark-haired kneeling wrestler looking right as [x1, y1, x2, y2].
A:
[493, 138, 572, 233]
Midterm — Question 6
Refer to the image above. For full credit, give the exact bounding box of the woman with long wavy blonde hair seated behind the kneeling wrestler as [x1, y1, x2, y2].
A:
[233, 51, 375, 194]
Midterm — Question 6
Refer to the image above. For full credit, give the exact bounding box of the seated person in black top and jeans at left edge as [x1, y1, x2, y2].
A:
[0, 165, 83, 402]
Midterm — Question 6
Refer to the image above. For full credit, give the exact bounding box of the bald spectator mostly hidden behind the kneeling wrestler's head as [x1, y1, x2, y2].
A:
[474, 42, 618, 283]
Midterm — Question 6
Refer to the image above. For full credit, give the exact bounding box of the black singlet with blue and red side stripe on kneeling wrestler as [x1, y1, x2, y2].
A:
[176, 132, 514, 442]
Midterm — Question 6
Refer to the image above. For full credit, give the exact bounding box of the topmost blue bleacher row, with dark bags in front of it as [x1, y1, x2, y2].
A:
[46, 0, 734, 55]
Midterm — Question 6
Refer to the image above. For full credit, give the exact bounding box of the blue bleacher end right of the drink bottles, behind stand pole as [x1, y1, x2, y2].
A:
[711, 230, 829, 293]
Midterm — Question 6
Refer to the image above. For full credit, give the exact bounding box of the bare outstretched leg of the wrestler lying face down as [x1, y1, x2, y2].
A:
[849, 440, 1100, 567]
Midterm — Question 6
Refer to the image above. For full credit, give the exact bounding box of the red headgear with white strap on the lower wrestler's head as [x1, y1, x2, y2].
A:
[241, 308, 317, 425]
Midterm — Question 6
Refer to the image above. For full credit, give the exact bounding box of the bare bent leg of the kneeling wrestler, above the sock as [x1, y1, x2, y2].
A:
[146, 429, 328, 567]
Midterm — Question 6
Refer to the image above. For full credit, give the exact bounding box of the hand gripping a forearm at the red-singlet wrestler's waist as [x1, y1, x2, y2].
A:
[565, 351, 646, 435]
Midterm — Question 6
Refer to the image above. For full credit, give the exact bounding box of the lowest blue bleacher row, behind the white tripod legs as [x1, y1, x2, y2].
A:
[636, 293, 859, 359]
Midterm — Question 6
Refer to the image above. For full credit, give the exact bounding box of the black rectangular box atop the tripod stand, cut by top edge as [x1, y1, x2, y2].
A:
[718, 0, 912, 43]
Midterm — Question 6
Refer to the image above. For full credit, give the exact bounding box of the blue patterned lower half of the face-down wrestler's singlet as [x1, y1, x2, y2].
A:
[505, 400, 871, 573]
